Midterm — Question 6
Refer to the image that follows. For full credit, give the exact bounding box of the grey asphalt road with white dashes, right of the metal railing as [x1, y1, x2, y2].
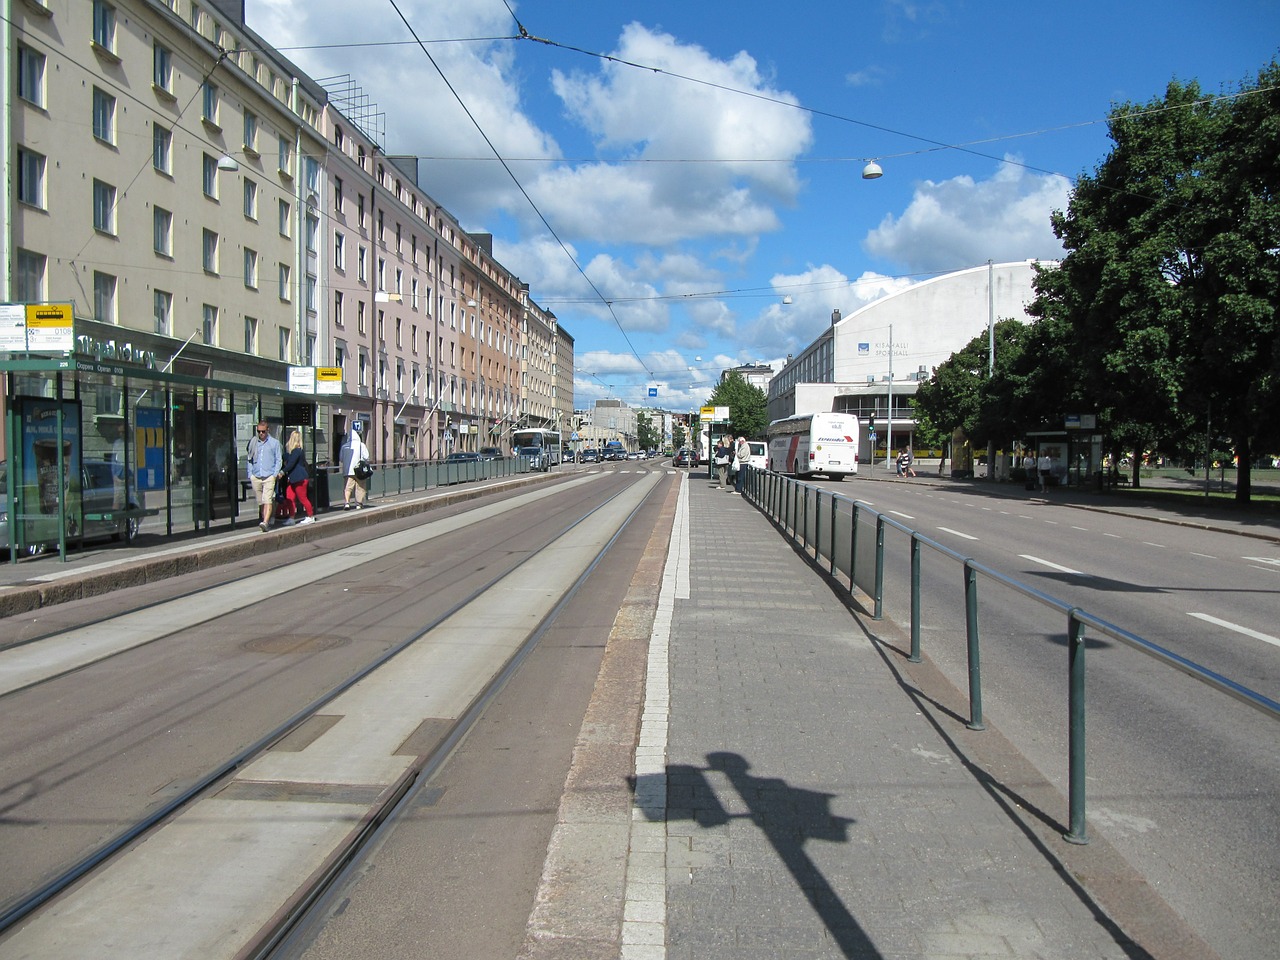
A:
[814, 481, 1280, 957]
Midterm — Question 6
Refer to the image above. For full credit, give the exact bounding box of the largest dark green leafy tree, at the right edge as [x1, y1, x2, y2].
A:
[1021, 63, 1280, 500]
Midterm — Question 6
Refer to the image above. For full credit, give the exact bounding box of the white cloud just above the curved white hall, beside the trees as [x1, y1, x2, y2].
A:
[865, 164, 1071, 273]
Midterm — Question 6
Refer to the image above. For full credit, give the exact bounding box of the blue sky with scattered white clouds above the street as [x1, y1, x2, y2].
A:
[246, 0, 1280, 411]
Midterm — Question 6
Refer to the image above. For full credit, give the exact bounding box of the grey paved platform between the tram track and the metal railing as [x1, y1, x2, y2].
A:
[645, 474, 1211, 960]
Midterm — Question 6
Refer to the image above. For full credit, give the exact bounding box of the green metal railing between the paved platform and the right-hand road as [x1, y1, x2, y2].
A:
[745, 468, 1280, 844]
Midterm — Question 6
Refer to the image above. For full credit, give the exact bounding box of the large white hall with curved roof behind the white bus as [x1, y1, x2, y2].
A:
[768, 260, 1037, 461]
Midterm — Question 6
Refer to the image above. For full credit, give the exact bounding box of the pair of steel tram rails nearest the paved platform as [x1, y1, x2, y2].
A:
[0, 471, 657, 957]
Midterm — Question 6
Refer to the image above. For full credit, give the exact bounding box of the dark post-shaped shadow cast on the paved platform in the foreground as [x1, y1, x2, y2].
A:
[636, 753, 881, 960]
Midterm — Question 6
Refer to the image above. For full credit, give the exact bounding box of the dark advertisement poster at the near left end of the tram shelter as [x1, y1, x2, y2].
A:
[18, 398, 81, 544]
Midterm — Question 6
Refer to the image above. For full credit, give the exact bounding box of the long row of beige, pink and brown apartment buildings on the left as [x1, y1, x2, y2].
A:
[0, 0, 572, 555]
